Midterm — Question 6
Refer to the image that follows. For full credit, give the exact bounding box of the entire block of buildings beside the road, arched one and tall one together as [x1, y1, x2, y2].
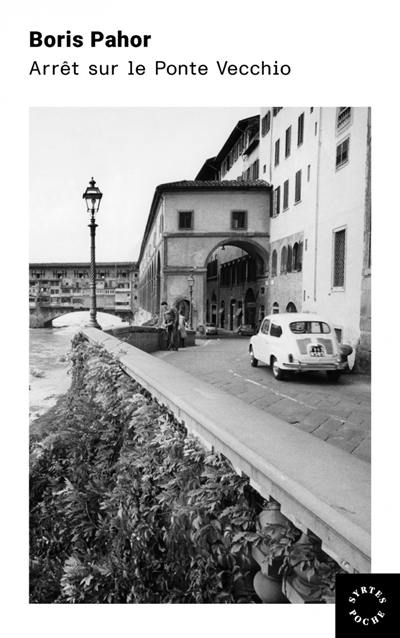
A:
[139, 107, 371, 368]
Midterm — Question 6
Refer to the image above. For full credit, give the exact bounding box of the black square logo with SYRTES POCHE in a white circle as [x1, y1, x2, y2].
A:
[336, 574, 400, 638]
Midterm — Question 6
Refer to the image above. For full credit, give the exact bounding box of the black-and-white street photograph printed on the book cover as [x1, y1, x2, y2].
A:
[29, 106, 371, 605]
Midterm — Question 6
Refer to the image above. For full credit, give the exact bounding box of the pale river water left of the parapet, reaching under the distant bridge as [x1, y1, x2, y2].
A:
[29, 312, 126, 422]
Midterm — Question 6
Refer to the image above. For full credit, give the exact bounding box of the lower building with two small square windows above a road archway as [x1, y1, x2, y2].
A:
[139, 180, 271, 327]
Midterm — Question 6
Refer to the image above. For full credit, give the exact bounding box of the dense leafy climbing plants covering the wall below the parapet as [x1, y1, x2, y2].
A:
[30, 335, 260, 603]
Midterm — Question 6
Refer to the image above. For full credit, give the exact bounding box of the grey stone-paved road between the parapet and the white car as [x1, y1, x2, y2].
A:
[154, 338, 371, 462]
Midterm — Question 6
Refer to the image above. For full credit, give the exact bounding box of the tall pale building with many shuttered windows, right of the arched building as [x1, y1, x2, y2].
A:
[197, 107, 371, 369]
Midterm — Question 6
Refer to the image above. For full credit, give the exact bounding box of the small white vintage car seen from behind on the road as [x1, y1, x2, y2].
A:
[249, 312, 347, 381]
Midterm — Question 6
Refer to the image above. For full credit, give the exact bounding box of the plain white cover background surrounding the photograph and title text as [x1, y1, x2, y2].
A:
[0, 0, 400, 638]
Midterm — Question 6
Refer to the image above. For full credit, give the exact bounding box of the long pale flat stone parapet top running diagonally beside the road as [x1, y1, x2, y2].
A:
[84, 329, 371, 578]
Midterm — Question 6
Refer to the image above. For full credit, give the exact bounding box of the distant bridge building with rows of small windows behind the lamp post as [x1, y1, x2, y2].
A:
[29, 262, 138, 326]
